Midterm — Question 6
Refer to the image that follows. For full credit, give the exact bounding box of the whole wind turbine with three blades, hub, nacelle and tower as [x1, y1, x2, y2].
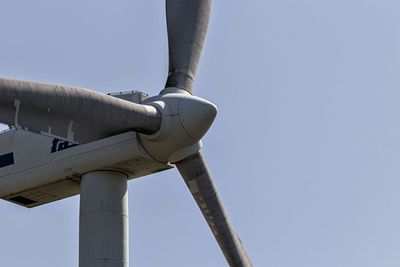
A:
[0, 0, 252, 267]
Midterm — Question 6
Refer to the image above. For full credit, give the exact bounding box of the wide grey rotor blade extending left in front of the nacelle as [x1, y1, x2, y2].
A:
[0, 79, 161, 143]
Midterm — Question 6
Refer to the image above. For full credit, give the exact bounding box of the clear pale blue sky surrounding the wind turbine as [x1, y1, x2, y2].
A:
[0, 0, 400, 267]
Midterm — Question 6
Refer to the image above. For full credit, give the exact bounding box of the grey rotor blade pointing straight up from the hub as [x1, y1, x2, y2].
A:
[165, 0, 211, 93]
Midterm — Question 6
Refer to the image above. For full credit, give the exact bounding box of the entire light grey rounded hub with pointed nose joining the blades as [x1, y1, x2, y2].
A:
[139, 87, 217, 163]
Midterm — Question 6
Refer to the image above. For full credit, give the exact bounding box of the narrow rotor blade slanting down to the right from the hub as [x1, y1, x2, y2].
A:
[176, 152, 253, 267]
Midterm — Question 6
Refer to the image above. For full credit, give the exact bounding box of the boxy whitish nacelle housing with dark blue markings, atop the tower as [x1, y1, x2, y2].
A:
[0, 128, 173, 208]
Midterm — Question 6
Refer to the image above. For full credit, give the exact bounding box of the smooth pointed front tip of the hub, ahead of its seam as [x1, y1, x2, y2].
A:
[179, 95, 217, 141]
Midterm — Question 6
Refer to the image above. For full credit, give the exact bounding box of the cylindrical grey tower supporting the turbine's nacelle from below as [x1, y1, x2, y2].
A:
[79, 171, 129, 267]
